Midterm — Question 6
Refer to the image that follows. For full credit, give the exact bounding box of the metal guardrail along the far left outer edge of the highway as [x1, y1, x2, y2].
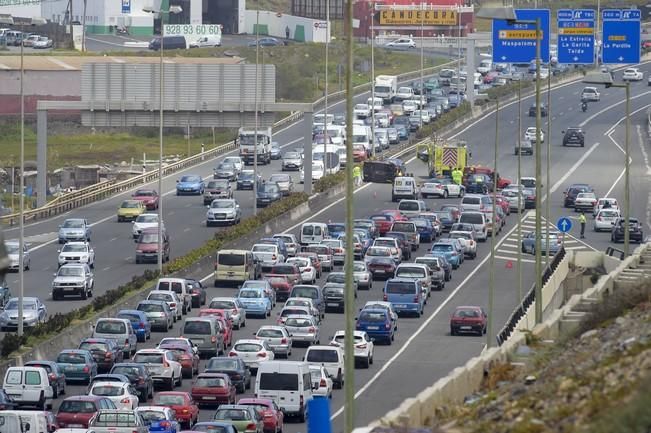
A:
[0, 60, 456, 226]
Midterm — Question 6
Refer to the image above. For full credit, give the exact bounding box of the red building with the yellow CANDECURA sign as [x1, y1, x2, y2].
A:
[353, 0, 474, 38]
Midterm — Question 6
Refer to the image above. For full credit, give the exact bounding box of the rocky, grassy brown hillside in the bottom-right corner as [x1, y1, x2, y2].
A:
[432, 285, 651, 433]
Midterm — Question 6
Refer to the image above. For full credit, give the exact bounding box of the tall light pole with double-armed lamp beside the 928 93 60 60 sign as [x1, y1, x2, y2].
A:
[142, 6, 183, 275]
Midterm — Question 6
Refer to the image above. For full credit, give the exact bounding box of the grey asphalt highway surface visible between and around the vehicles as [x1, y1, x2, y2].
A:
[7, 59, 651, 433]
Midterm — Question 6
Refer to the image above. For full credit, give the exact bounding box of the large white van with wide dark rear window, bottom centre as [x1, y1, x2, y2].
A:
[255, 361, 312, 422]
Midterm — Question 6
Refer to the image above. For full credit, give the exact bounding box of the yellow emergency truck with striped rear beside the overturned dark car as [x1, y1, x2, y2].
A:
[416, 137, 472, 177]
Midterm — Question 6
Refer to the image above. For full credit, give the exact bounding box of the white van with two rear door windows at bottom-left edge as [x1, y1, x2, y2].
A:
[2, 367, 54, 410]
